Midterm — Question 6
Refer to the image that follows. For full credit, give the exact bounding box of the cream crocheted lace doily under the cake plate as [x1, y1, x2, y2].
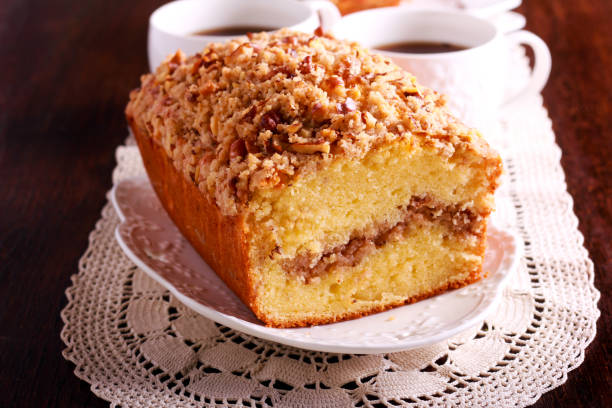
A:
[61, 55, 599, 407]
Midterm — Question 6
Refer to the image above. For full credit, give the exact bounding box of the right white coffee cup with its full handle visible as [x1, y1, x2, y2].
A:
[332, 7, 551, 130]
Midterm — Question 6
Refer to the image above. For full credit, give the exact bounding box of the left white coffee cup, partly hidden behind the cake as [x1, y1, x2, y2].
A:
[148, 0, 340, 71]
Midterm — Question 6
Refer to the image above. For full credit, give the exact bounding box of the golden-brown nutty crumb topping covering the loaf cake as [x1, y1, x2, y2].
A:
[127, 29, 479, 215]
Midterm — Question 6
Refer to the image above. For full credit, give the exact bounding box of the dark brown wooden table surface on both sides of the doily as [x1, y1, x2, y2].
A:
[0, 0, 612, 407]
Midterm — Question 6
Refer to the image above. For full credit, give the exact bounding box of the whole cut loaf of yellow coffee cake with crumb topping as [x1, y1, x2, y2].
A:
[126, 30, 501, 327]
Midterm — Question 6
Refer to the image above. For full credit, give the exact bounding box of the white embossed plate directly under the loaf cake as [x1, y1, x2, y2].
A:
[111, 178, 521, 354]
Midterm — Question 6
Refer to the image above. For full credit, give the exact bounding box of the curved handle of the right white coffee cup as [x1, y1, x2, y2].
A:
[502, 30, 552, 107]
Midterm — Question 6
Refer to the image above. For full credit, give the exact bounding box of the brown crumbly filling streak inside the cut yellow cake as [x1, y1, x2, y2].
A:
[282, 196, 482, 283]
